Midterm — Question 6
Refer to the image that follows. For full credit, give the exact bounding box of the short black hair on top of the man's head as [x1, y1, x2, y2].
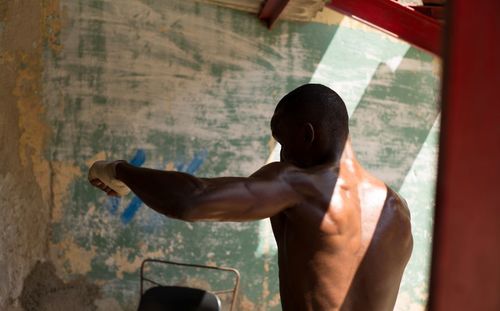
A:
[275, 84, 349, 150]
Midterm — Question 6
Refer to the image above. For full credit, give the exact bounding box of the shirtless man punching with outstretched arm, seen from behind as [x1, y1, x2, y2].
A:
[89, 84, 413, 311]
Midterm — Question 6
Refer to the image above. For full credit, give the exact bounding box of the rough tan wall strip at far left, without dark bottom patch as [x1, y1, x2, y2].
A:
[0, 1, 50, 310]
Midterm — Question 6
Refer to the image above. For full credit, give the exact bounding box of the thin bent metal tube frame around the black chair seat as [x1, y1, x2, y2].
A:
[140, 258, 240, 311]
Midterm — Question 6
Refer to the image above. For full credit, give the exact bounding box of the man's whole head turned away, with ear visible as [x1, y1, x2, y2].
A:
[271, 84, 349, 167]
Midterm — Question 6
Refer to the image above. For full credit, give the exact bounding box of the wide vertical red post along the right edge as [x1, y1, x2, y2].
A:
[429, 0, 500, 311]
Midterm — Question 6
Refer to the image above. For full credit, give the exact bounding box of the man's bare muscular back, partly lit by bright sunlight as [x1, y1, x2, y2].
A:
[257, 144, 412, 311]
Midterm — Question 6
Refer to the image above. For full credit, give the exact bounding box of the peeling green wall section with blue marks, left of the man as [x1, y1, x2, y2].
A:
[44, 1, 336, 310]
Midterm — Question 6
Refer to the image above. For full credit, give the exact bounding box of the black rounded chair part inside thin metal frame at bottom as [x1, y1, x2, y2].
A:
[138, 286, 220, 311]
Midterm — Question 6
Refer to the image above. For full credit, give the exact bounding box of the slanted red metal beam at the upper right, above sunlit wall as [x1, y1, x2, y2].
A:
[327, 0, 443, 56]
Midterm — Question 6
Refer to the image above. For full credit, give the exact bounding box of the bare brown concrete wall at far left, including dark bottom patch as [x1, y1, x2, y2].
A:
[0, 0, 101, 311]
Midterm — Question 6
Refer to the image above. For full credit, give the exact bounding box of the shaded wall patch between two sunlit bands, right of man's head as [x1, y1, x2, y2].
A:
[350, 48, 439, 191]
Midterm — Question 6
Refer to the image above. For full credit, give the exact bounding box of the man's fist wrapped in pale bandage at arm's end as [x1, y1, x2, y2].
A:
[88, 161, 130, 196]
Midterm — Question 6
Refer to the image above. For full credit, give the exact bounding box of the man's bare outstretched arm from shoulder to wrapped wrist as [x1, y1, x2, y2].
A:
[89, 161, 302, 221]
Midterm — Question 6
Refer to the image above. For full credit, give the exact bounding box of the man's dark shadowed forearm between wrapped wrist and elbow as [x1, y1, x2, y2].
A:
[115, 161, 203, 220]
